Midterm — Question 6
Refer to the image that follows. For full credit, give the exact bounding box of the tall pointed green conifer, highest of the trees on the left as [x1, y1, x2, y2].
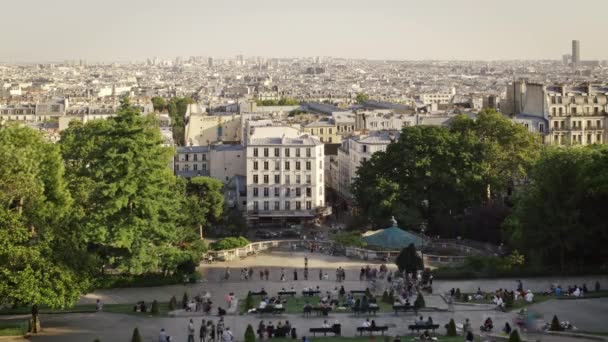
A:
[60, 99, 190, 274]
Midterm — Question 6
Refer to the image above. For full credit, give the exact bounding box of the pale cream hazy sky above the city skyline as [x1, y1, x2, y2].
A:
[0, 0, 608, 62]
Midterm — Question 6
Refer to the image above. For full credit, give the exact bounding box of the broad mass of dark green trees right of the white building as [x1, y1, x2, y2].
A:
[353, 111, 608, 270]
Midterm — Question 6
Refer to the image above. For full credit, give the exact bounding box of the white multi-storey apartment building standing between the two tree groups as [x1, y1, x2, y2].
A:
[246, 127, 326, 225]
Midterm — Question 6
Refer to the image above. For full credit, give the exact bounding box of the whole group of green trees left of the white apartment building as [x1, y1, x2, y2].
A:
[0, 99, 223, 307]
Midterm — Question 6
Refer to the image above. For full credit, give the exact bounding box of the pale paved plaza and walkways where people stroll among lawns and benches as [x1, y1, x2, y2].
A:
[4, 252, 608, 342]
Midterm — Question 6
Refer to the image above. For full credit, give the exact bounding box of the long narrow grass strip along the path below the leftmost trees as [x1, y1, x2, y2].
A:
[0, 303, 169, 317]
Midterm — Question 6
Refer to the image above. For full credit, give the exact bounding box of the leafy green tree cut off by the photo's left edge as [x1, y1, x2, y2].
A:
[0, 125, 90, 322]
